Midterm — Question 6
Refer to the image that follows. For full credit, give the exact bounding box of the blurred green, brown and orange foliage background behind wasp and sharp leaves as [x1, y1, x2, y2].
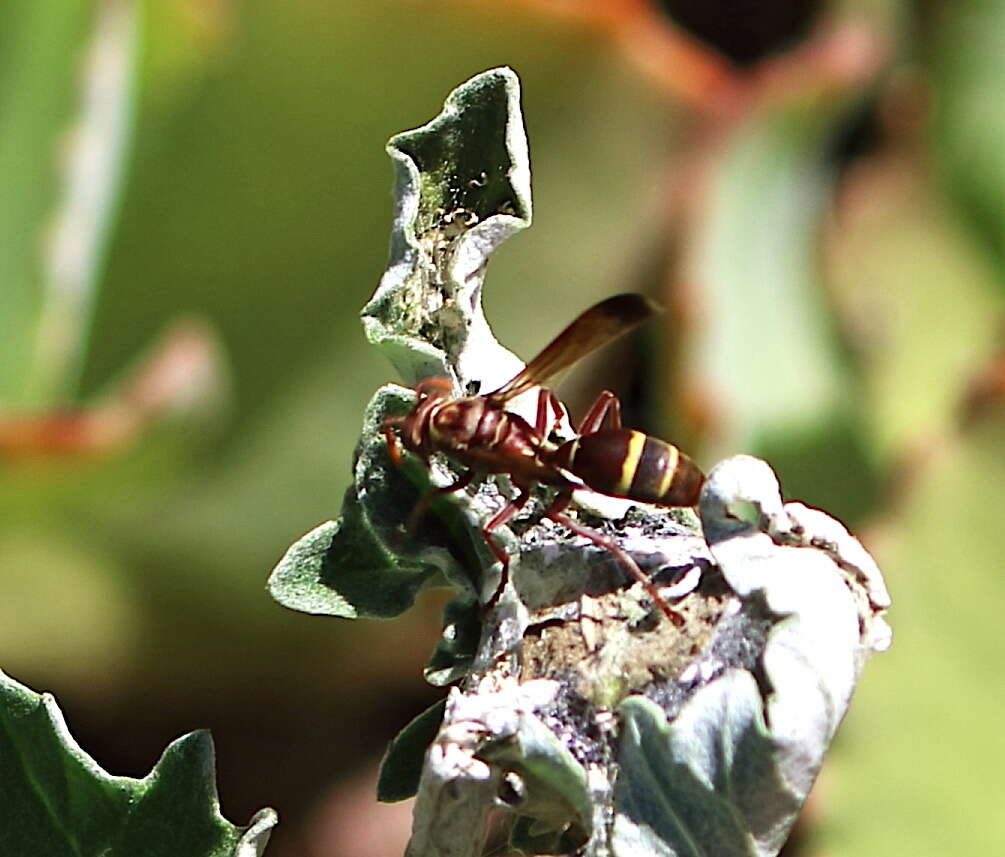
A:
[0, 0, 1005, 857]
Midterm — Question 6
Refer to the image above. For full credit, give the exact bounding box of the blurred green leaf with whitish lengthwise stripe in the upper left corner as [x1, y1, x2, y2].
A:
[0, 0, 140, 407]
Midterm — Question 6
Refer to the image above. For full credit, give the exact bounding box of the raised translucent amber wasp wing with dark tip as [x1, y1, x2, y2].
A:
[488, 293, 658, 402]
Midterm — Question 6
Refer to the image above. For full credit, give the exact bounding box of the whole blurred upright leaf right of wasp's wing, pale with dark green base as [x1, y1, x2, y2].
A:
[686, 92, 876, 517]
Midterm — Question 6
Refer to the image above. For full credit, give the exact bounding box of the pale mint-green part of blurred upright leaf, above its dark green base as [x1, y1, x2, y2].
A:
[694, 103, 842, 438]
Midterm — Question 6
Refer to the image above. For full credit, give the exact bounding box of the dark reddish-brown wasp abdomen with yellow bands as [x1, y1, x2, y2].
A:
[555, 429, 705, 505]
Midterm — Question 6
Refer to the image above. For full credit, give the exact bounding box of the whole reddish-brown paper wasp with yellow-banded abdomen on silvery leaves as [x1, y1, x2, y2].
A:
[384, 294, 705, 625]
